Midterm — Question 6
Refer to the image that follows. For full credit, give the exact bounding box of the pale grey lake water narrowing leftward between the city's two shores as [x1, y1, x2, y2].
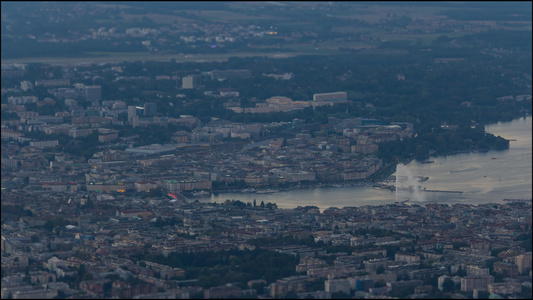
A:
[199, 116, 532, 210]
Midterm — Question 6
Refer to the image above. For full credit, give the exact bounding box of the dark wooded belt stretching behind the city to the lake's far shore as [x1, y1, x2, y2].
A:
[8, 45, 532, 160]
